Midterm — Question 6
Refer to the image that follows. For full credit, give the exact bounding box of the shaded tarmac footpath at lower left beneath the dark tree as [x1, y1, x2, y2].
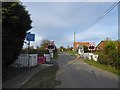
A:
[2, 64, 53, 89]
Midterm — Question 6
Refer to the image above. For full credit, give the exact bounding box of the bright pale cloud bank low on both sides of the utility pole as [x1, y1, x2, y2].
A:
[63, 21, 118, 45]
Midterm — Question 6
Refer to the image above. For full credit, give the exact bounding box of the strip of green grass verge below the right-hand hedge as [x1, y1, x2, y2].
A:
[83, 60, 120, 76]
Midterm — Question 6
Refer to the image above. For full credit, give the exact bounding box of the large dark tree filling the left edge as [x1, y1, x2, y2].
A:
[2, 2, 32, 68]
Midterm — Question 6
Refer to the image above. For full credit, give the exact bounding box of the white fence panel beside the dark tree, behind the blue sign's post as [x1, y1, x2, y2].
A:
[12, 54, 38, 67]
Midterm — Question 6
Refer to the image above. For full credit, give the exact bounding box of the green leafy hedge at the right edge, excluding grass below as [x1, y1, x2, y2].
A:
[95, 41, 120, 69]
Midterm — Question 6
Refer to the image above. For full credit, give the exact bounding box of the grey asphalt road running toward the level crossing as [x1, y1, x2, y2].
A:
[56, 53, 118, 88]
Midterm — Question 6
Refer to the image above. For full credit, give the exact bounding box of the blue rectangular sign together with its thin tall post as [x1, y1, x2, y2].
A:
[26, 32, 35, 66]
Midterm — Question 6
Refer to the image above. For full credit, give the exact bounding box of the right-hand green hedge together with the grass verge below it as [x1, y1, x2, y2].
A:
[84, 41, 120, 75]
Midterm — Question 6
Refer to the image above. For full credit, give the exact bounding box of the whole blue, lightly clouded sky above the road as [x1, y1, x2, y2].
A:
[23, 0, 118, 47]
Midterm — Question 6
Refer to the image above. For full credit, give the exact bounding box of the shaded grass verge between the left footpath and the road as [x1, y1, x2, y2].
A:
[21, 65, 60, 88]
